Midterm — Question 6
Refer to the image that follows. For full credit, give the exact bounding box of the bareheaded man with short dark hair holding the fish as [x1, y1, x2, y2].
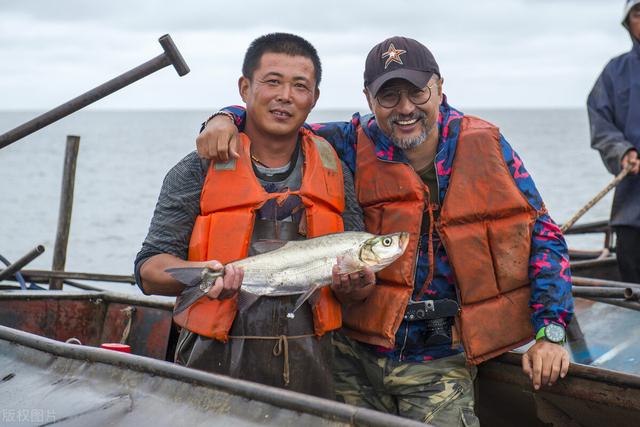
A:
[135, 33, 375, 399]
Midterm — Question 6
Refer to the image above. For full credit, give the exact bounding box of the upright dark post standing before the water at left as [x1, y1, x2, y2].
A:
[49, 135, 80, 290]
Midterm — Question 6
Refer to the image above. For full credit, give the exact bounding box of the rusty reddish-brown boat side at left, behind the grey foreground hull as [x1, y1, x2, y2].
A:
[0, 290, 176, 360]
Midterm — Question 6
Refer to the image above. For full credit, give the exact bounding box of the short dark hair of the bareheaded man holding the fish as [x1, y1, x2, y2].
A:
[242, 33, 322, 87]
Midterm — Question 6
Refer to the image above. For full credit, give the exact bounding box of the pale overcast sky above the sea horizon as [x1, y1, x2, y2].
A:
[0, 0, 631, 110]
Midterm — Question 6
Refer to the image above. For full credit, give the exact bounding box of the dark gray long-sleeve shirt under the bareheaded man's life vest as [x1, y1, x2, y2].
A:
[134, 151, 364, 292]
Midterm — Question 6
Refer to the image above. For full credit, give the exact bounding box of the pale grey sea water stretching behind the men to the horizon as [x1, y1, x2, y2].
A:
[0, 109, 612, 292]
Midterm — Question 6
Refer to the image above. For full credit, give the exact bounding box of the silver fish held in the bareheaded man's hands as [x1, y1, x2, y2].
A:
[165, 231, 409, 317]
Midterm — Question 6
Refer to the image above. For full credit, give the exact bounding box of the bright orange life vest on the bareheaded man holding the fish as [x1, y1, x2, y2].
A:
[174, 129, 344, 342]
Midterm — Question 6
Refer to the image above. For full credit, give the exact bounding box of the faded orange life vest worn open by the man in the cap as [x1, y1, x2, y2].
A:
[350, 116, 538, 364]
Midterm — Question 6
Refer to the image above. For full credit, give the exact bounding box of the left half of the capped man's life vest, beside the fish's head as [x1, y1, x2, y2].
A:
[342, 128, 429, 347]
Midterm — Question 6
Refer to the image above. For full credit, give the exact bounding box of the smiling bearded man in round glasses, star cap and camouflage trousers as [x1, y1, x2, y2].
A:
[197, 37, 573, 425]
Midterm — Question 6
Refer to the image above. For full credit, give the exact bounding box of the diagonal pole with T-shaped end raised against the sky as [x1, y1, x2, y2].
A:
[0, 34, 189, 149]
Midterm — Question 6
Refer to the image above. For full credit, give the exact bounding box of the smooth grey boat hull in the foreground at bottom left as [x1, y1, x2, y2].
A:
[0, 326, 424, 427]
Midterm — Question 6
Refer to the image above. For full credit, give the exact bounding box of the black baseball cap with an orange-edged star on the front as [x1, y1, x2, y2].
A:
[364, 37, 440, 96]
